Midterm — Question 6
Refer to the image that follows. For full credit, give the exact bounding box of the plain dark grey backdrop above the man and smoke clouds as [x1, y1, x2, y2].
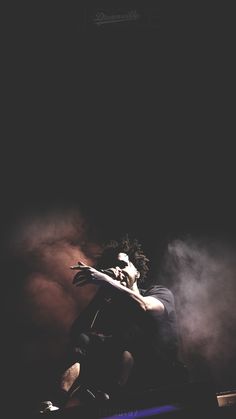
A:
[1, 1, 236, 416]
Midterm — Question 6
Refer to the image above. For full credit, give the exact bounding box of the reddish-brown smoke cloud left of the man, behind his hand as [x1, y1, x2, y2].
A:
[6, 210, 98, 368]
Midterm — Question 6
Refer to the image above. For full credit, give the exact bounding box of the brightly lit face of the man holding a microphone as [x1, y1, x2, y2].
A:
[111, 253, 140, 288]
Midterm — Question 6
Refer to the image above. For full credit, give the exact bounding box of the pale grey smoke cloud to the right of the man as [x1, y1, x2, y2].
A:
[163, 238, 236, 379]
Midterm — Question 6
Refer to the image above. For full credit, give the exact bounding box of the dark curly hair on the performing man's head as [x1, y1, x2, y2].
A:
[96, 234, 149, 283]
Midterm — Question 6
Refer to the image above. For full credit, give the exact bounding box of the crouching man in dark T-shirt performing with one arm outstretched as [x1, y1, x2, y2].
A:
[58, 236, 185, 408]
